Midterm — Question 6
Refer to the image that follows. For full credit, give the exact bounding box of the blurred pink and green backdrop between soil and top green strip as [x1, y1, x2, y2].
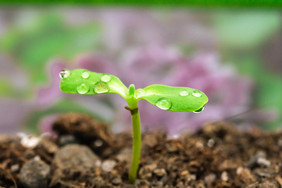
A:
[0, 6, 282, 135]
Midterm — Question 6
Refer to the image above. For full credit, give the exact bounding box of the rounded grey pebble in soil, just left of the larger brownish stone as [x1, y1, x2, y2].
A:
[20, 157, 50, 188]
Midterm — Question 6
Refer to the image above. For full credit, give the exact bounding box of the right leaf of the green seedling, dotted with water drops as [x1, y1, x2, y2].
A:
[136, 85, 208, 112]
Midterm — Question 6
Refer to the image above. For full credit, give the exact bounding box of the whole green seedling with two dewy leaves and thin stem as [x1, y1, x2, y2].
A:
[60, 69, 208, 183]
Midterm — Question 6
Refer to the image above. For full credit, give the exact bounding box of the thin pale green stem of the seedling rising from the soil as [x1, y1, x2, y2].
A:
[127, 84, 142, 184]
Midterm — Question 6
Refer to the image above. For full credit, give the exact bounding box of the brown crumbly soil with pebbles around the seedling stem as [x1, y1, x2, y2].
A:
[0, 113, 282, 188]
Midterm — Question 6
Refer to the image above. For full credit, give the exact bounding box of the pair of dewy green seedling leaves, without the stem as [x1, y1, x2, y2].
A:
[60, 69, 208, 112]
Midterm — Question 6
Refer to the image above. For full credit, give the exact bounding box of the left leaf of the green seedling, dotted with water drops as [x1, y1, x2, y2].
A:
[60, 69, 128, 98]
